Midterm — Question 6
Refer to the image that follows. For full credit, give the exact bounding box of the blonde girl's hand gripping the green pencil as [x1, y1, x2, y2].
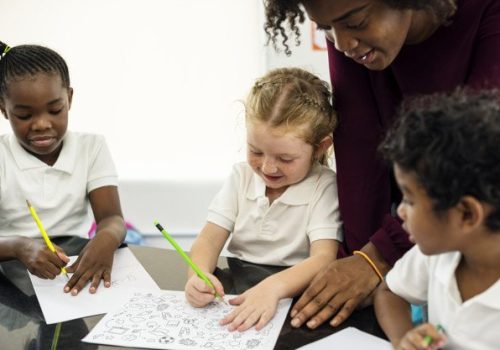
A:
[184, 272, 224, 307]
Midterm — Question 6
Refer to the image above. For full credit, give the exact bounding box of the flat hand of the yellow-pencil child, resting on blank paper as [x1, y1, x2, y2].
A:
[64, 233, 116, 295]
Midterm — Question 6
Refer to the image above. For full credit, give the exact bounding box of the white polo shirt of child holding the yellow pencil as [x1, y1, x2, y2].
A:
[0, 132, 118, 237]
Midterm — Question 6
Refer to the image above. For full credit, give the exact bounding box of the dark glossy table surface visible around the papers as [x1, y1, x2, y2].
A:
[0, 237, 384, 350]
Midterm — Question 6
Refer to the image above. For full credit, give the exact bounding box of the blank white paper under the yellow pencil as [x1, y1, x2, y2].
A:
[28, 248, 160, 324]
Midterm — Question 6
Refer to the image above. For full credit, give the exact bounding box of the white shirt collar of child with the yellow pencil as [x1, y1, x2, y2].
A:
[9, 132, 76, 174]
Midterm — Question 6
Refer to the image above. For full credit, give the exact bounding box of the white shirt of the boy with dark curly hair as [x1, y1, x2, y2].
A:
[386, 246, 500, 350]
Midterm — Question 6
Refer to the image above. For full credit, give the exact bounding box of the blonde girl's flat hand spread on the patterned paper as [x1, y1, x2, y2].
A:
[220, 280, 280, 332]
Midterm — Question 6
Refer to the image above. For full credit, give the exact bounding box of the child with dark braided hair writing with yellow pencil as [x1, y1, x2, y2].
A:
[0, 42, 125, 295]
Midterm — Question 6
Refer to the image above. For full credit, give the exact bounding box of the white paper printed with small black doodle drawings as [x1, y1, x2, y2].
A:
[82, 290, 292, 350]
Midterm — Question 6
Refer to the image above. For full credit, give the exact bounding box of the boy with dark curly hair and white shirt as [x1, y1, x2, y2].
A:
[375, 90, 500, 349]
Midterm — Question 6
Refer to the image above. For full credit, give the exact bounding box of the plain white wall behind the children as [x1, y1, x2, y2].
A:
[0, 0, 334, 233]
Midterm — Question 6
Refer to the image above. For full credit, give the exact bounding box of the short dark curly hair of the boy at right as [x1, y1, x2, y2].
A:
[380, 89, 500, 231]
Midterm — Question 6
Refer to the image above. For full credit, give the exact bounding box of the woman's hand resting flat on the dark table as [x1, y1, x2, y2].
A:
[291, 255, 380, 329]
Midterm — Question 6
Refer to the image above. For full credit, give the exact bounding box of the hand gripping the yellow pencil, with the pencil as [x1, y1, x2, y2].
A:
[23, 200, 69, 279]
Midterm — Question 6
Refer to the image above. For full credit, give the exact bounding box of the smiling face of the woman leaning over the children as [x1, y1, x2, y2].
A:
[303, 0, 412, 70]
